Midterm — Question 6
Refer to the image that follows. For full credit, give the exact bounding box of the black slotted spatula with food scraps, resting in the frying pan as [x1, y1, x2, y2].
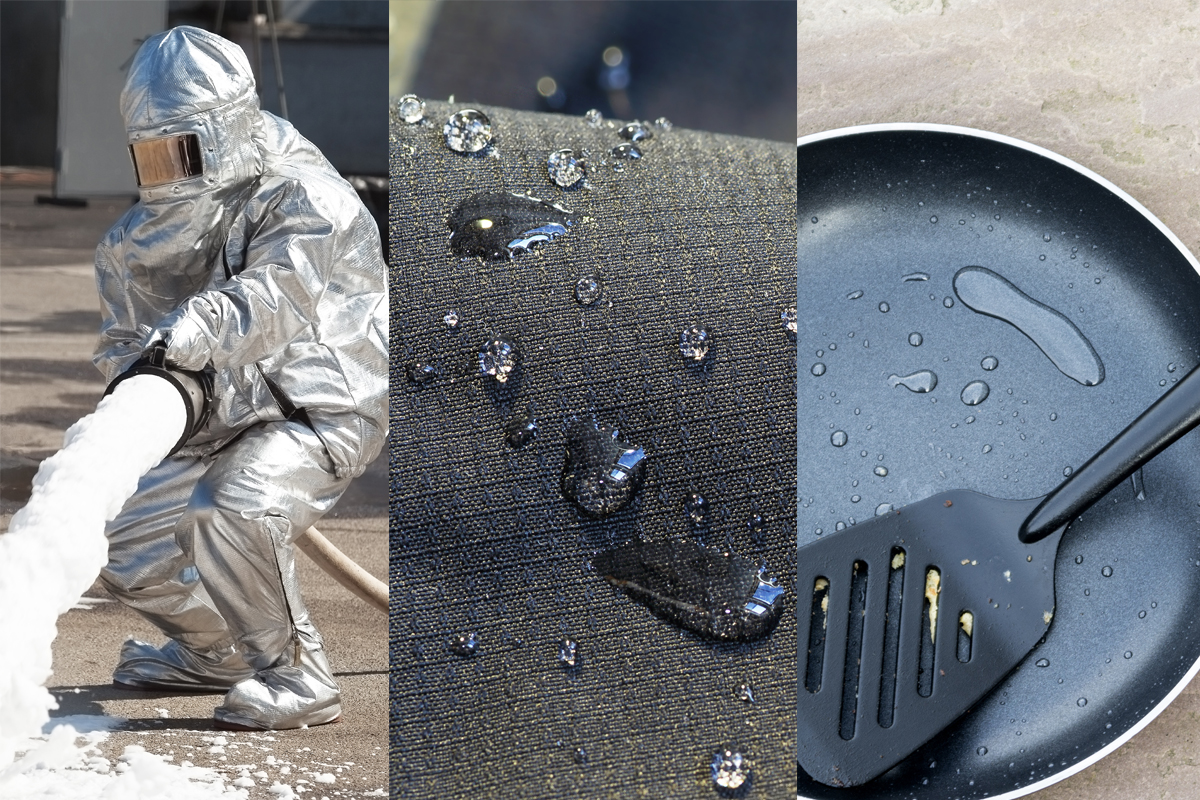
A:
[796, 367, 1200, 786]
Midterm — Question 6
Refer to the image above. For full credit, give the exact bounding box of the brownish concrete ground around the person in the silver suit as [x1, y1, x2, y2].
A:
[0, 168, 388, 799]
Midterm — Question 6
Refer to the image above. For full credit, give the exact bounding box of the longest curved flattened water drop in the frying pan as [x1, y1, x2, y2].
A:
[954, 266, 1104, 386]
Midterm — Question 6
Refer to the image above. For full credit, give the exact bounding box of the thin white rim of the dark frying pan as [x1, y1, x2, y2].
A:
[796, 122, 1200, 800]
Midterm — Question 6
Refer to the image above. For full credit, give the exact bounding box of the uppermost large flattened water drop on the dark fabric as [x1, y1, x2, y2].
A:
[446, 192, 575, 259]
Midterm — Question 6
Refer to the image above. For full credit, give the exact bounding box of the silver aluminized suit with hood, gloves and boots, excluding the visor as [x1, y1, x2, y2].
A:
[94, 28, 388, 728]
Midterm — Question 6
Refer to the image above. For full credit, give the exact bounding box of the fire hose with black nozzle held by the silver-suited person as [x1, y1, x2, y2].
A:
[111, 345, 388, 613]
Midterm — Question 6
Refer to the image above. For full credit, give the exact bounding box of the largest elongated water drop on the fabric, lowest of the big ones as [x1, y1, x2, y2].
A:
[592, 540, 785, 642]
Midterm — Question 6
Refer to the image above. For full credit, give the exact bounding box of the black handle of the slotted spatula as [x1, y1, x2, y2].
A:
[1020, 366, 1200, 543]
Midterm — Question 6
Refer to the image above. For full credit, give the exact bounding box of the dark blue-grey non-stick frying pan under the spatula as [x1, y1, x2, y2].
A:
[797, 126, 1200, 800]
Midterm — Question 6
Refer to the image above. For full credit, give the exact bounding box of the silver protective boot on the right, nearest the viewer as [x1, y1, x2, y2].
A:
[212, 638, 342, 730]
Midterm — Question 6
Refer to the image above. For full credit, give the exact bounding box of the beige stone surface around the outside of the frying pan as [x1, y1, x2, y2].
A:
[797, 0, 1200, 800]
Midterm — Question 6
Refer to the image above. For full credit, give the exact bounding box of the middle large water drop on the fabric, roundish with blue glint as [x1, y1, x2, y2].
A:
[560, 417, 646, 519]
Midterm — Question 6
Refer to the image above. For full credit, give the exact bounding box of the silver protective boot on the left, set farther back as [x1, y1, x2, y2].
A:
[113, 639, 254, 692]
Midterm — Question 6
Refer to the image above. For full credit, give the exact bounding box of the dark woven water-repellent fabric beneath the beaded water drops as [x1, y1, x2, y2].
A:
[390, 102, 797, 799]
